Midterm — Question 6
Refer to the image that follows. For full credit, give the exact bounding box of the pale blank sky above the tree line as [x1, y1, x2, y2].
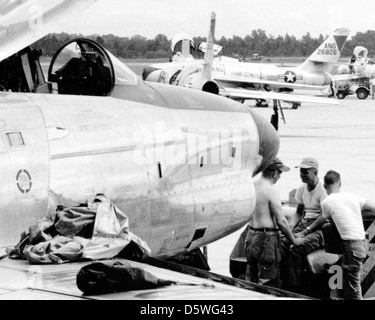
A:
[58, 0, 375, 39]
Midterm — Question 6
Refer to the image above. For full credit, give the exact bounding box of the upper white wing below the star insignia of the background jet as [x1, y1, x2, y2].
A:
[213, 75, 326, 90]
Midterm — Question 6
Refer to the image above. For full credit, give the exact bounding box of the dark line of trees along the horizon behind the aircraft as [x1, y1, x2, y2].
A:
[35, 29, 375, 59]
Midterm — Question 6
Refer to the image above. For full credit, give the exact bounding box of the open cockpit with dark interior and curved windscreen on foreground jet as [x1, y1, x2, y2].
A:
[0, 38, 139, 96]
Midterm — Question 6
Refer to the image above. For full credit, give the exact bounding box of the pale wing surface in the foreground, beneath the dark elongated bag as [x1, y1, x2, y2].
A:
[0, 252, 309, 301]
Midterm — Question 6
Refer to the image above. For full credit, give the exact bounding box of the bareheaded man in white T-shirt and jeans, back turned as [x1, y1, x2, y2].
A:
[321, 170, 375, 300]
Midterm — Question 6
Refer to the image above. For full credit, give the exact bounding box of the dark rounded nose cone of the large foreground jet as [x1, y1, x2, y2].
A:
[248, 109, 280, 176]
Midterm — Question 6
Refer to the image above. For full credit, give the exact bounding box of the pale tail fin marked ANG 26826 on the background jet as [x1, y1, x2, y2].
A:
[302, 28, 350, 67]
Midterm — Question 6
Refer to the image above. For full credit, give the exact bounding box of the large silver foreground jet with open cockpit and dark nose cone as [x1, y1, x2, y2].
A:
[0, 0, 279, 264]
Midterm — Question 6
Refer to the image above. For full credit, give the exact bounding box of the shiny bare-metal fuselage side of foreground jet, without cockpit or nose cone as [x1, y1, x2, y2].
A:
[0, 81, 274, 256]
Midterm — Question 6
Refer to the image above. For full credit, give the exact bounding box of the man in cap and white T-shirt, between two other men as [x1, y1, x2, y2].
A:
[283, 158, 327, 293]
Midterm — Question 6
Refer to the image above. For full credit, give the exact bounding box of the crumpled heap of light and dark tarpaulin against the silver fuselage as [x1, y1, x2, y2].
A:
[16, 195, 151, 264]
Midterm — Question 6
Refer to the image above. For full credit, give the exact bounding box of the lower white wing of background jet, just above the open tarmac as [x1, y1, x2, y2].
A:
[220, 88, 339, 105]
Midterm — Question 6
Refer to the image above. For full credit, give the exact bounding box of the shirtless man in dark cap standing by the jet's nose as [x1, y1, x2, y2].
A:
[245, 158, 302, 288]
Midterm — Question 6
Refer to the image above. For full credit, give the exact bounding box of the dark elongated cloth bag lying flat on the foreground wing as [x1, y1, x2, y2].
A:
[77, 261, 176, 295]
